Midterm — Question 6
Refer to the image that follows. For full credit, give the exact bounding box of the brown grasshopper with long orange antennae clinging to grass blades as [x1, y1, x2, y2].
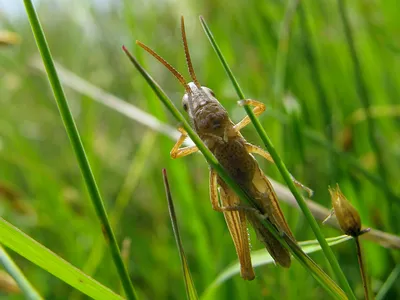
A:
[136, 17, 311, 280]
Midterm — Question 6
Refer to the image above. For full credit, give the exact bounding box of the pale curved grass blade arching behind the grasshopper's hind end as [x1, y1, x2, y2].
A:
[200, 235, 352, 299]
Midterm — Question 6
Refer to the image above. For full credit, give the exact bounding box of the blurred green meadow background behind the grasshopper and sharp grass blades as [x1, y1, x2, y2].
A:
[0, 0, 400, 299]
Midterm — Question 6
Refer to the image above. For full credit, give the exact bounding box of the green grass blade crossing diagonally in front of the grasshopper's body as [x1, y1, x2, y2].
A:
[123, 46, 346, 299]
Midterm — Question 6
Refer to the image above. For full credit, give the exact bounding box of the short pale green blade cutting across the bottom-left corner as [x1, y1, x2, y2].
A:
[0, 245, 43, 300]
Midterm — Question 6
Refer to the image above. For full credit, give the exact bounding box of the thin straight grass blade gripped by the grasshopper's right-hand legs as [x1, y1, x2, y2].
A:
[200, 17, 355, 299]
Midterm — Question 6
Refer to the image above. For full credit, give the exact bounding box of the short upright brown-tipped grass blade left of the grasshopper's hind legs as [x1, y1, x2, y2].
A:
[163, 169, 198, 300]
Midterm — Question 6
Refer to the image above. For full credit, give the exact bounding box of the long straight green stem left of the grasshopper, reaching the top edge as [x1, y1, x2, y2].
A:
[24, 0, 136, 299]
